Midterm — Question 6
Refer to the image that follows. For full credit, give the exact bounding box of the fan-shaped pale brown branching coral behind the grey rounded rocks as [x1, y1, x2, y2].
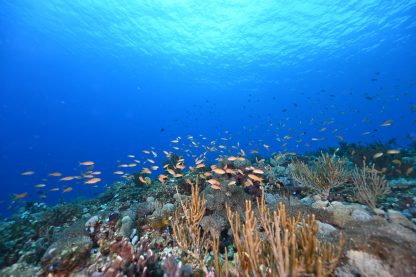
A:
[291, 153, 349, 199]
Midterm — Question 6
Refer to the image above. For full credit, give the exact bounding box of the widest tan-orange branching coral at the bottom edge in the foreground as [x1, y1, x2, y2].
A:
[226, 192, 344, 276]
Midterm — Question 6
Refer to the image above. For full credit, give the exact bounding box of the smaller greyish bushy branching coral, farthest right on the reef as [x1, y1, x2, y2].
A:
[352, 162, 390, 209]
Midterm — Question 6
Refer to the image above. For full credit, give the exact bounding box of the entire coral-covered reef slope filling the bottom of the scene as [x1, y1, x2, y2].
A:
[0, 145, 416, 277]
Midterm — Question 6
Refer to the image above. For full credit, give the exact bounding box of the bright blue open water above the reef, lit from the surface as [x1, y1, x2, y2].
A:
[0, 0, 416, 213]
